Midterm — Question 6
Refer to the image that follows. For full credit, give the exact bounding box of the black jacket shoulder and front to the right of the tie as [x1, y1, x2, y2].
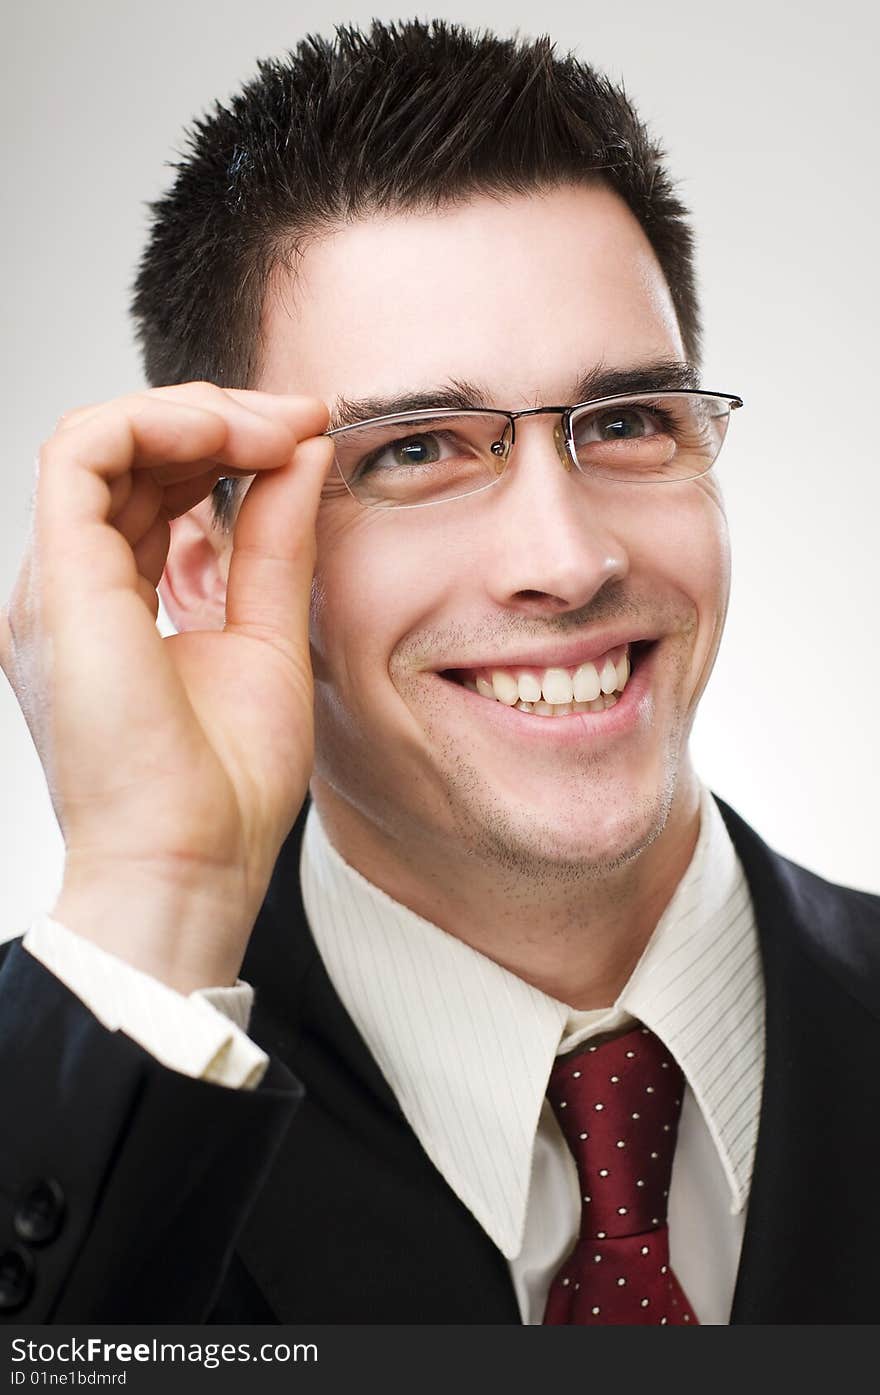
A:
[717, 799, 880, 1324]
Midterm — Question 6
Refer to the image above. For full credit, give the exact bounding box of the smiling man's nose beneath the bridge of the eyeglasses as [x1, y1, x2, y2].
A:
[484, 417, 629, 615]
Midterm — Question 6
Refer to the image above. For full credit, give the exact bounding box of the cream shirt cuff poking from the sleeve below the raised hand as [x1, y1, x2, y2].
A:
[24, 915, 269, 1089]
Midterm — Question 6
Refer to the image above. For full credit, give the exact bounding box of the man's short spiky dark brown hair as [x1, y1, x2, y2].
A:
[132, 20, 700, 530]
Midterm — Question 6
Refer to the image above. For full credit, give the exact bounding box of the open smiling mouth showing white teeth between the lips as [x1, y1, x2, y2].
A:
[439, 640, 657, 717]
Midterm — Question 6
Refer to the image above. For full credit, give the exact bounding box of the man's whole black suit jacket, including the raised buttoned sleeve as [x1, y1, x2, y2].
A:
[0, 801, 880, 1324]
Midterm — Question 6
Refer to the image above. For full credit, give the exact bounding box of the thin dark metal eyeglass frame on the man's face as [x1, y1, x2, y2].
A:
[324, 388, 743, 509]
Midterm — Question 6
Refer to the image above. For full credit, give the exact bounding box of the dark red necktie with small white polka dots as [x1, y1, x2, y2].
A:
[544, 1027, 697, 1327]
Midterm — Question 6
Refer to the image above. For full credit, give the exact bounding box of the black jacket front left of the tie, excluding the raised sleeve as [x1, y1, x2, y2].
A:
[238, 809, 519, 1324]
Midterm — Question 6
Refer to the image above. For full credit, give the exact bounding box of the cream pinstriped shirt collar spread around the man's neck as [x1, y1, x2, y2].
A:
[300, 787, 763, 1258]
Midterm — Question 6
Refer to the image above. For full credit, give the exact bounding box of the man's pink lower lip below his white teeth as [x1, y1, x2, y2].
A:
[441, 643, 660, 745]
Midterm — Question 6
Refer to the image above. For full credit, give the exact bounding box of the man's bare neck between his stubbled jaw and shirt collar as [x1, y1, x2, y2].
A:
[311, 767, 700, 1010]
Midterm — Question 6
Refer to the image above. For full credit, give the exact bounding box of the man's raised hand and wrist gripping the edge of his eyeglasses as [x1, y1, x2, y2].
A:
[0, 382, 332, 992]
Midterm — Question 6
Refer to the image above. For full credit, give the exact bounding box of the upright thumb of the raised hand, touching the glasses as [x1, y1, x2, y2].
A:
[226, 437, 333, 650]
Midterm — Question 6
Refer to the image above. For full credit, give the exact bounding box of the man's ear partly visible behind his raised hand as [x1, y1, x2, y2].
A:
[158, 498, 232, 632]
